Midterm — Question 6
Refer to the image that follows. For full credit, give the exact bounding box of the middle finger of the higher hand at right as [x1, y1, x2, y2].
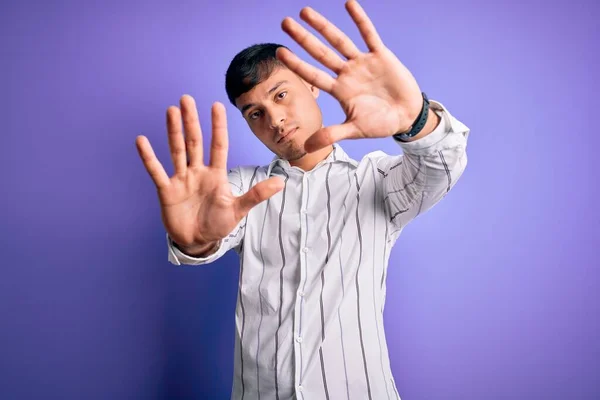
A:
[281, 17, 346, 74]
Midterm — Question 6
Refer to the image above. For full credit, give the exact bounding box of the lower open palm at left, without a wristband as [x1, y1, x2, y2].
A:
[136, 95, 284, 249]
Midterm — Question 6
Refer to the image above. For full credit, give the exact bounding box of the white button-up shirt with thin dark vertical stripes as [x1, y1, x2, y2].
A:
[167, 100, 469, 400]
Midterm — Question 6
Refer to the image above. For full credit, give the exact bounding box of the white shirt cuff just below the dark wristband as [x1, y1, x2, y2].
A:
[394, 100, 467, 155]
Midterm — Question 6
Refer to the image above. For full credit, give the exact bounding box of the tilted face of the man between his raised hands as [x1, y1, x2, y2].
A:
[236, 67, 323, 161]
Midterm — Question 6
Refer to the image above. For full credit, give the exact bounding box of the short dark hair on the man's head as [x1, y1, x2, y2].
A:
[225, 43, 287, 106]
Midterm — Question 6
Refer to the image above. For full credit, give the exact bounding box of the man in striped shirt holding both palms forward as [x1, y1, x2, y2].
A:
[137, 1, 469, 400]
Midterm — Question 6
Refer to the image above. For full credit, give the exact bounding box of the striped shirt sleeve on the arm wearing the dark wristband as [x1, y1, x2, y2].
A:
[378, 100, 470, 229]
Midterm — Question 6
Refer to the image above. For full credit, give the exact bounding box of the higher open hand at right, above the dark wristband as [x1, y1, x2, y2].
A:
[277, 0, 423, 152]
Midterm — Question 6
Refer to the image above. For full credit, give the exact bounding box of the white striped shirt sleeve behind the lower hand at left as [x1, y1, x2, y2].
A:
[167, 167, 248, 265]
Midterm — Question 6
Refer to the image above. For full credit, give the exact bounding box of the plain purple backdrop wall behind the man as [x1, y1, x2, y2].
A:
[0, 0, 600, 400]
